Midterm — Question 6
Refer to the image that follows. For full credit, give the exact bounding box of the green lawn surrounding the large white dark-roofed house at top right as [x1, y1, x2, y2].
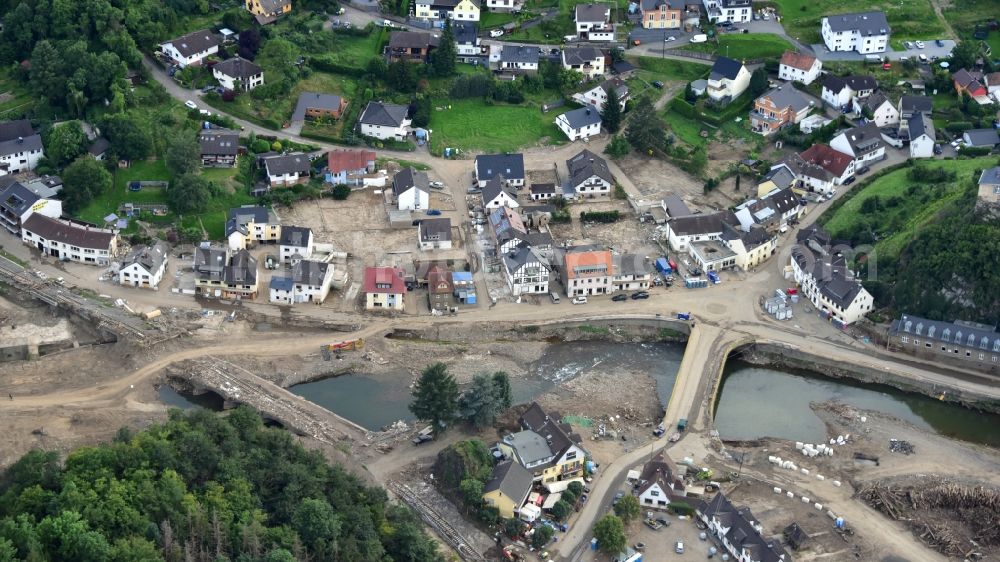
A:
[774, 0, 944, 45]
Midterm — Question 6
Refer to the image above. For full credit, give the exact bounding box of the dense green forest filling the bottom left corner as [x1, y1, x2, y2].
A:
[0, 407, 440, 562]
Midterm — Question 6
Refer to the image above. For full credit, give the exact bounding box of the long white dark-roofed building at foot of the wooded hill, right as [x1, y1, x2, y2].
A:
[791, 227, 874, 327]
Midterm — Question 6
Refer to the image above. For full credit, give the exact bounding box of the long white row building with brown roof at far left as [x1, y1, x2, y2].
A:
[21, 212, 118, 266]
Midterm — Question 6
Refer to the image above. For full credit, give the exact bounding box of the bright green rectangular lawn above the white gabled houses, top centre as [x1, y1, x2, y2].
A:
[430, 99, 567, 154]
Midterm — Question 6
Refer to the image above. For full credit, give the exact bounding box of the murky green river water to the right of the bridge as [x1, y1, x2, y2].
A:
[715, 360, 1000, 447]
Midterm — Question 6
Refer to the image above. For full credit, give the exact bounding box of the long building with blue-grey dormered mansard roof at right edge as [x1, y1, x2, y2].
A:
[887, 314, 1000, 374]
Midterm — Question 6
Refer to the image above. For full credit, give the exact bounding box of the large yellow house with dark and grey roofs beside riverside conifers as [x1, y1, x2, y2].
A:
[497, 403, 587, 484]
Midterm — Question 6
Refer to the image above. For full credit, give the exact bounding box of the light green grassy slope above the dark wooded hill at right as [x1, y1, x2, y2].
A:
[820, 158, 995, 257]
